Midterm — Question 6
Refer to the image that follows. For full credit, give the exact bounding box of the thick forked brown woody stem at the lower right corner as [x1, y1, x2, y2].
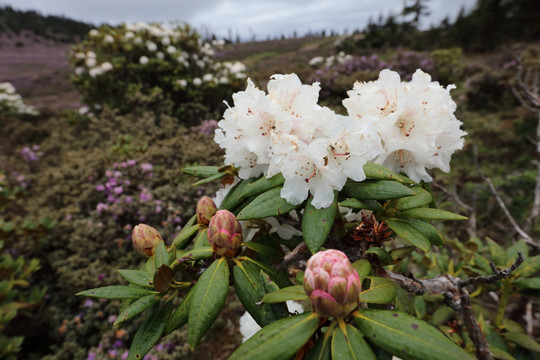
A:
[387, 252, 524, 360]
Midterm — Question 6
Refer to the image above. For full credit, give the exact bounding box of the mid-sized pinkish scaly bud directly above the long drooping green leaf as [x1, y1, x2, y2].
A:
[208, 210, 242, 257]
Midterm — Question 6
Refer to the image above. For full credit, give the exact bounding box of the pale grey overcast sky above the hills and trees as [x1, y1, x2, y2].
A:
[0, 0, 476, 40]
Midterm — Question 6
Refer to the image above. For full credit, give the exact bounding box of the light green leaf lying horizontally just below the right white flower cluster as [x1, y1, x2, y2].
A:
[340, 180, 414, 200]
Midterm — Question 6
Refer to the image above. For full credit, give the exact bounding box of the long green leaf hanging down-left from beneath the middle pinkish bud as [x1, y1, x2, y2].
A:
[188, 258, 229, 349]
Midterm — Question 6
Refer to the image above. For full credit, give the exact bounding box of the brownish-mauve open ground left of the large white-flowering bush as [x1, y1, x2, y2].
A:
[0, 34, 81, 110]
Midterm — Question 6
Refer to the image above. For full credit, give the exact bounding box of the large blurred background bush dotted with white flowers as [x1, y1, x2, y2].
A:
[70, 23, 246, 121]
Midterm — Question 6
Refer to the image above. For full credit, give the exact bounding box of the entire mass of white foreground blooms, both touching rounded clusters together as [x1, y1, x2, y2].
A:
[215, 70, 466, 208]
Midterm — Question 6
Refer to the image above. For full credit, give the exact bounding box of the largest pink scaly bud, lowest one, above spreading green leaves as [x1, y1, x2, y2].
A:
[304, 250, 362, 318]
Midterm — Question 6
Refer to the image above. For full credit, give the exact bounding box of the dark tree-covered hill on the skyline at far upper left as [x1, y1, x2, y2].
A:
[0, 6, 95, 44]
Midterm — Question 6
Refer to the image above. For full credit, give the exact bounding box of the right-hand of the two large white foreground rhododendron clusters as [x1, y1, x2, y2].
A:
[343, 70, 466, 181]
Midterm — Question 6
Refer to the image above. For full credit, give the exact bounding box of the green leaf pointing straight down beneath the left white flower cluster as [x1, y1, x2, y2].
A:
[302, 192, 338, 254]
